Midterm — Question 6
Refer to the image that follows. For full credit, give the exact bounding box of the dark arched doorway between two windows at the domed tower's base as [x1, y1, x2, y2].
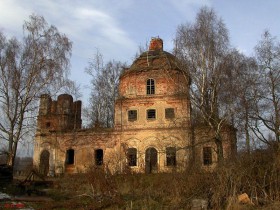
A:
[145, 147, 158, 174]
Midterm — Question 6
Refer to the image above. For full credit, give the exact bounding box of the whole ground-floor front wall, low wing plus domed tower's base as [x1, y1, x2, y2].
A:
[31, 125, 191, 175]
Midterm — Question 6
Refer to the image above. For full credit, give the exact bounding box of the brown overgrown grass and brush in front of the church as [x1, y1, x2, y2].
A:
[30, 148, 280, 209]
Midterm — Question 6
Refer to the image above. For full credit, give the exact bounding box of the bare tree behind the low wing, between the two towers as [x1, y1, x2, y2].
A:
[86, 52, 125, 128]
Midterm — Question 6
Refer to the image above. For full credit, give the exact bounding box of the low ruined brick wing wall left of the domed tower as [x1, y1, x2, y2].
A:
[33, 130, 119, 175]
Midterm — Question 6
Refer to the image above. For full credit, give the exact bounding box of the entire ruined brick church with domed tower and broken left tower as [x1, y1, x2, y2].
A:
[33, 38, 236, 175]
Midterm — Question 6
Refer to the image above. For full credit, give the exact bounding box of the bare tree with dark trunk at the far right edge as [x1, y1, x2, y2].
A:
[253, 31, 280, 148]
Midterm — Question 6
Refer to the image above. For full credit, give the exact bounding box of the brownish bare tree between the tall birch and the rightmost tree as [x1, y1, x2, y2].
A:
[225, 50, 257, 153]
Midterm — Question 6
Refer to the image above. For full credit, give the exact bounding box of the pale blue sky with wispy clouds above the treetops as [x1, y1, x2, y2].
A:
[0, 0, 280, 103]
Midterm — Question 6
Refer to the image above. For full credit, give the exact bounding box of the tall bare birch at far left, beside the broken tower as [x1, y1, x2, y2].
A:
[0, 15, 72, 166]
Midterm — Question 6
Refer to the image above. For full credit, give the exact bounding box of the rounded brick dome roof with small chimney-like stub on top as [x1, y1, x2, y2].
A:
[122, 38, 180, 76]
